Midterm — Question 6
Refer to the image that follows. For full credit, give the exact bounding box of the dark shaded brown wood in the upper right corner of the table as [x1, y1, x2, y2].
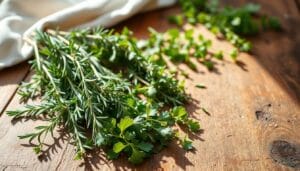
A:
[225, 0, 300, 105]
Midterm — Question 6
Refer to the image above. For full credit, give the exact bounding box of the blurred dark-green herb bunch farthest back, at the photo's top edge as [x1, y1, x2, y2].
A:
[169, 0, 281, 52]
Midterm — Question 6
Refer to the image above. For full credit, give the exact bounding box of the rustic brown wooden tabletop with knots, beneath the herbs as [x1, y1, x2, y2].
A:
[0, 0, 300, 171]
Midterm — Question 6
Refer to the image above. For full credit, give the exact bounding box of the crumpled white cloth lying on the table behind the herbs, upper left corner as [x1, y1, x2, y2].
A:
[0, 0, 175, 70]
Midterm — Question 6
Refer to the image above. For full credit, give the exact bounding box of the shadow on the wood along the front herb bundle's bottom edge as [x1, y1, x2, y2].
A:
[80, 141, 195, 170]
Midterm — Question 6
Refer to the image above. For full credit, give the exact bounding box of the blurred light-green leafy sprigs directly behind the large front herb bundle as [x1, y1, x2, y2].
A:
[138, 28, 225, 70]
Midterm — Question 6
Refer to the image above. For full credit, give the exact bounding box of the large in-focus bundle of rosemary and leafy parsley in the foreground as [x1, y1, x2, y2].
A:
[7, 28, 200, 164]
